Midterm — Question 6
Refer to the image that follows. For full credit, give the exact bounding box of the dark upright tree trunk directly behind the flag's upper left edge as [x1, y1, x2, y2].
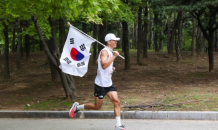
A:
[59, 18, 66, 54]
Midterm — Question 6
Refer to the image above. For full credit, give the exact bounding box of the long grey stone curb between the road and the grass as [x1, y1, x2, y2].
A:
[0, 111, 218, 121]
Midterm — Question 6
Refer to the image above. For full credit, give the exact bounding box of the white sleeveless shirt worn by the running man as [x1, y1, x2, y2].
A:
[95, 47, 114, 87]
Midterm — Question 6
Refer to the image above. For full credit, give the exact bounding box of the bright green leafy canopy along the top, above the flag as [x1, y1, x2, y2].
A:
[6, 0, 129, 23]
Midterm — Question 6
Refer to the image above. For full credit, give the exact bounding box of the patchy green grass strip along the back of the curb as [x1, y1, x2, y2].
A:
[22, 86, 218, 111]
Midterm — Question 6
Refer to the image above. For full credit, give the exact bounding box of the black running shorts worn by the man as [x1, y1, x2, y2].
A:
[94, 84, 117, 99]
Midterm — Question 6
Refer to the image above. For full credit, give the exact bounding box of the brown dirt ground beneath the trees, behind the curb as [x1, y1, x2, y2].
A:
[0, 51, 218, 111]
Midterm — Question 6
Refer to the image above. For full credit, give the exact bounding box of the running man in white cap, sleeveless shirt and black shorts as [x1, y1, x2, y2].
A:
[69, 33, 126, 130]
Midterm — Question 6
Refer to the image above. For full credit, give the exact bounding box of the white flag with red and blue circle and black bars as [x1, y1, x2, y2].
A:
[59, 26, 95, 77]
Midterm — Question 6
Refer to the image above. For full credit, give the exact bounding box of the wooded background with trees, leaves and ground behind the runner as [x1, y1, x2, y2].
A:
[0, 0, 218, 111]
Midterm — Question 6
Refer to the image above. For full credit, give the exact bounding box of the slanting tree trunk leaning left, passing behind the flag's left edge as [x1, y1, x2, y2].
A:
[32, 17, 76, 101]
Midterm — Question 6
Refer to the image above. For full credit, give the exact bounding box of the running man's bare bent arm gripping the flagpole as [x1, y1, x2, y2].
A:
[100, 50, 119, 69]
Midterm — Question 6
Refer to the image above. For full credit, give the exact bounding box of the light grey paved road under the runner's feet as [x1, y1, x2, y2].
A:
[0, 118, 218, 130]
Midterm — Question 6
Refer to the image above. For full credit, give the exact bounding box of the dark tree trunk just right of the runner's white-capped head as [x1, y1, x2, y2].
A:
[122, 21, 130, 70]
